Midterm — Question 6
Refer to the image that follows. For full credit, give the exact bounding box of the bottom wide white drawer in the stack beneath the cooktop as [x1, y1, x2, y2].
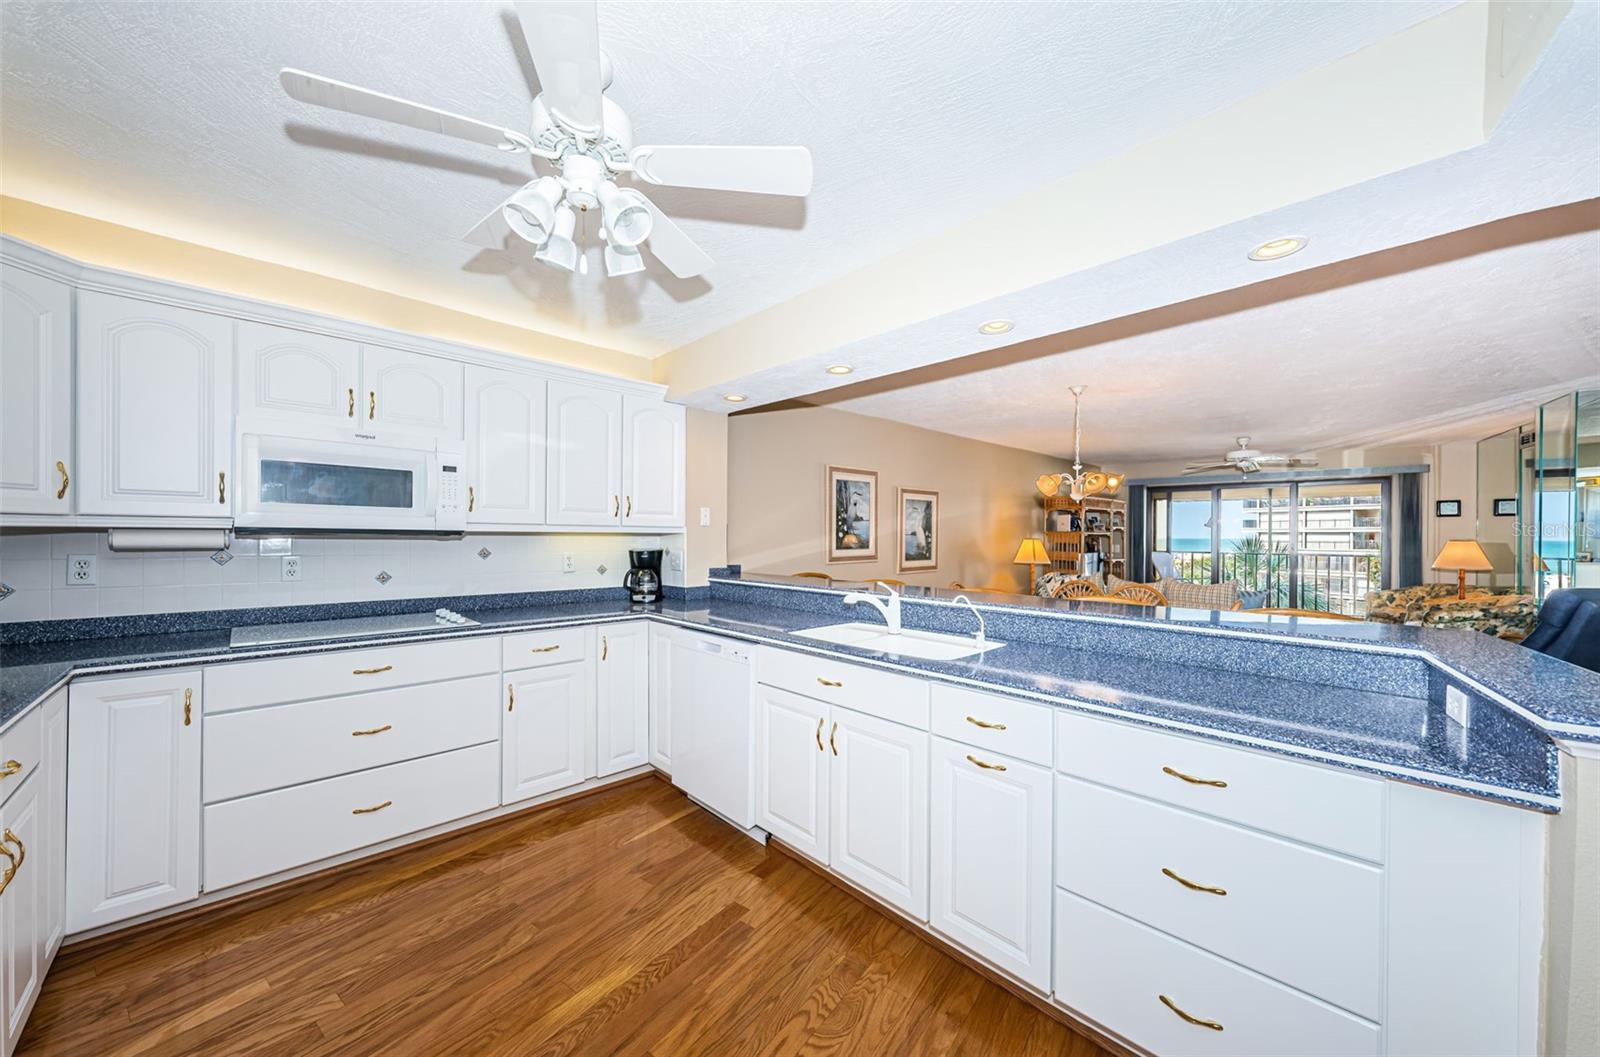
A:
[205, 744, 499, 892]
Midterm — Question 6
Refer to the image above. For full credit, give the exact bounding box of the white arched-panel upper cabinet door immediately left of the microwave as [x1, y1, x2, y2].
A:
[74, 291, 234, 517]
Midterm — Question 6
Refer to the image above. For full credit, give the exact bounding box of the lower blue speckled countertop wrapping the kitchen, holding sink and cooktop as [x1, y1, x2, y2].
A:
[0, 585, 1560, 811]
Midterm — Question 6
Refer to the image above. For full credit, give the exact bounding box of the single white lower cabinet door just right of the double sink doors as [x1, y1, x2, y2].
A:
[928, 732, 1053, 991]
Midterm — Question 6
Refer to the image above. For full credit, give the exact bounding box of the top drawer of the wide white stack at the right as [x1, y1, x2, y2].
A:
[1056, 710, 1384, 862]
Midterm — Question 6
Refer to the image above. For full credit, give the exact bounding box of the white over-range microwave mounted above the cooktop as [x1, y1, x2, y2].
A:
[234, 432, 467, 534]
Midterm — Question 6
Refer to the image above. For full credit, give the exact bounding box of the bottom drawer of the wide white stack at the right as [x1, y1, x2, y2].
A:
[1056, 889, 1378, 1057]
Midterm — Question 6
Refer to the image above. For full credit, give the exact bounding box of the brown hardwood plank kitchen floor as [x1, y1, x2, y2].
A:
[18, 779, 1106, 1057]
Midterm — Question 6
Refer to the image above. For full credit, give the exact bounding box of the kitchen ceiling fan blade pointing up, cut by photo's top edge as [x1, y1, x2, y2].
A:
[517, 0, 603, 139]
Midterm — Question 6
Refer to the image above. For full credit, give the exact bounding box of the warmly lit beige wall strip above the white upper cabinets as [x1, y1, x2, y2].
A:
[0, 197, 651, 379]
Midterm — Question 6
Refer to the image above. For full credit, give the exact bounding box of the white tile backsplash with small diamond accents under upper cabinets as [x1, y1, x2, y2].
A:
[0, 531, 683, 622]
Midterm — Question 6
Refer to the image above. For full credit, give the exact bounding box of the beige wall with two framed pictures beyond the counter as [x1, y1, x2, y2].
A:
[732, 408, 1062, 590]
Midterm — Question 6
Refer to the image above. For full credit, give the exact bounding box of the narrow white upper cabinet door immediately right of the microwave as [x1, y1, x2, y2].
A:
[467, 366, 546, 525]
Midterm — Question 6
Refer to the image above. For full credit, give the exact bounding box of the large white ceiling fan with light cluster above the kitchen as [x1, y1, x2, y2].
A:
[278, 0, 811, 278]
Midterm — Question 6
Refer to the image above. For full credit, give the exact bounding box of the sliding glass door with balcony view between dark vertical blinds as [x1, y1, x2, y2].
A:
[1150, 478, 1389, 617]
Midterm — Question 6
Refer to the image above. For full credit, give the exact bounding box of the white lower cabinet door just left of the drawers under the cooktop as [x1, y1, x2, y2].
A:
[67, 668, 202, 932]
